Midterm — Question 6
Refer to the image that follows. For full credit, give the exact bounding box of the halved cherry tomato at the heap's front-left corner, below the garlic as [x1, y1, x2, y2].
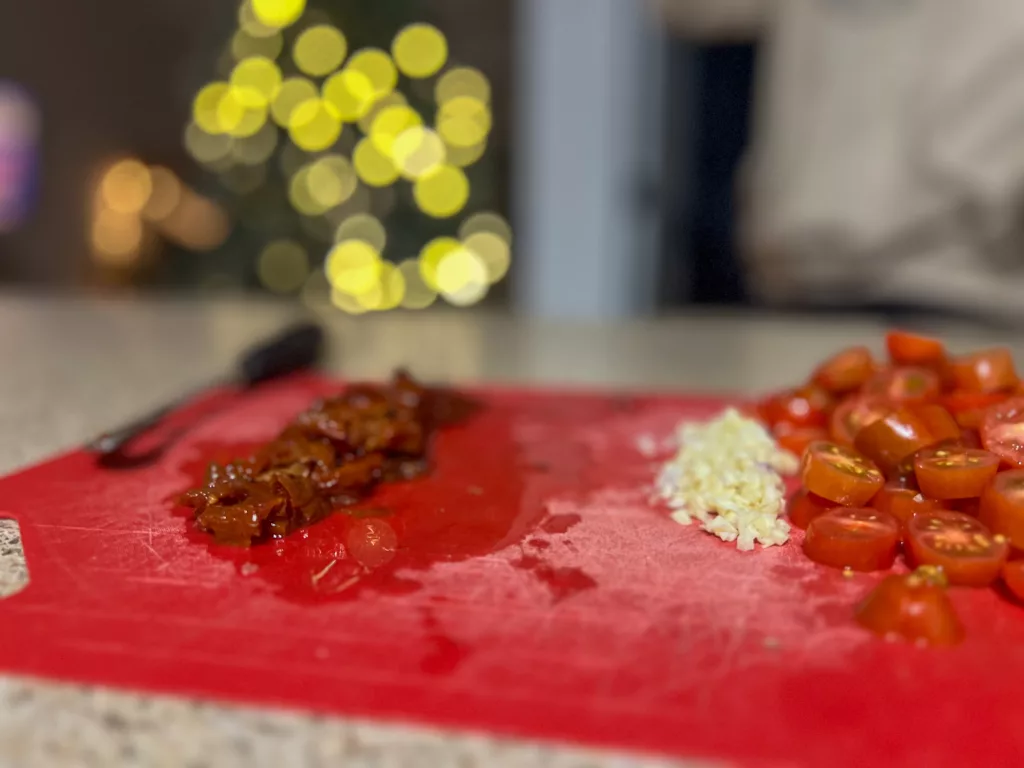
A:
[804, 507, 900, 570]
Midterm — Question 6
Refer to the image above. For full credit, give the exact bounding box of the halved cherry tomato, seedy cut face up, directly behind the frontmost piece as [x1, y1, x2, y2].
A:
[906, 511, 1010, 587]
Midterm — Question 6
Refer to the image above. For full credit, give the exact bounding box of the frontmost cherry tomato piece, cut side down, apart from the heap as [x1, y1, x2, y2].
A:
[854, 566, 964, 645]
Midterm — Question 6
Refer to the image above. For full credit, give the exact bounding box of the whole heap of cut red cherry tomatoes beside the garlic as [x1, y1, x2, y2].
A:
[758, 331, 1024, 644]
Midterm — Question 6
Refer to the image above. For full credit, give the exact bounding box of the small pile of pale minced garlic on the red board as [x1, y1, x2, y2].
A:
[657, 409, 799, 550]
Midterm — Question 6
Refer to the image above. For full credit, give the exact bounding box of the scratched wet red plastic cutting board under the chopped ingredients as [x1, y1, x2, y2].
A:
[0, 379, 1024, 768]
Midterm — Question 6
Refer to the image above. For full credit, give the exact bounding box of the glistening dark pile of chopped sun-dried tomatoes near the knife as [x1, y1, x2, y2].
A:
[179, 372, 468, 546]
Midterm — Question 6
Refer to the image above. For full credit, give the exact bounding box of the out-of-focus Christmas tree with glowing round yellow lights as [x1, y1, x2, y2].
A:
[178, 0, 511, 312]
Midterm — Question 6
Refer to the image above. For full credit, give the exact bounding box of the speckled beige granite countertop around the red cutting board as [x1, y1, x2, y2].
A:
[0, 296, 1007, 768]
